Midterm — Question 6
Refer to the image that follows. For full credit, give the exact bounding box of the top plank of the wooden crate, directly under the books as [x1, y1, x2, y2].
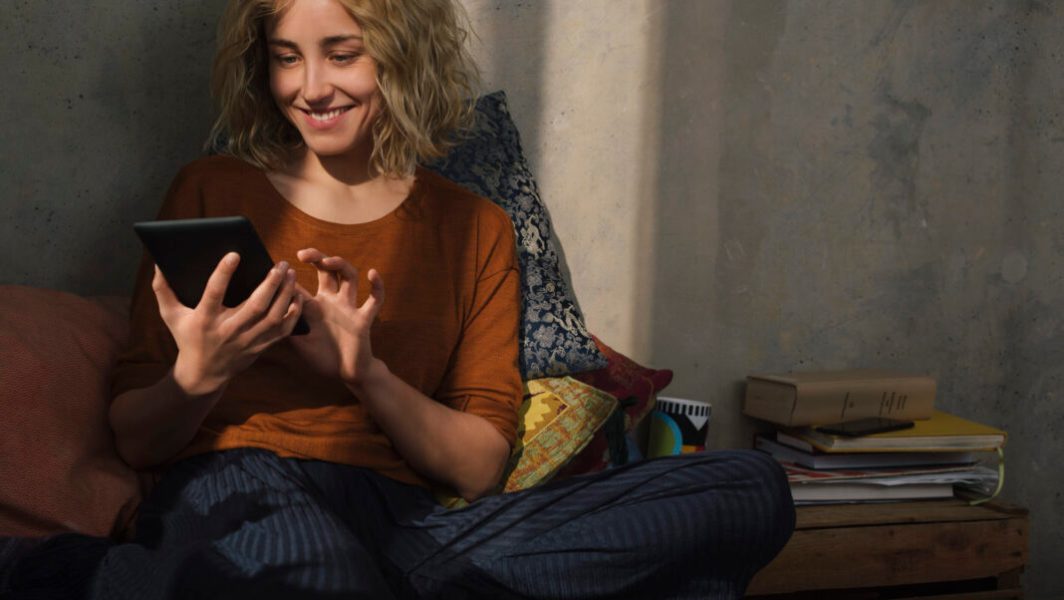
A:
[796, 499, 1027, 530]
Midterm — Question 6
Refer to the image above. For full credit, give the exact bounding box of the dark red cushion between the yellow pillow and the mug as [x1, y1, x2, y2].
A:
[555, 336, 672, 479]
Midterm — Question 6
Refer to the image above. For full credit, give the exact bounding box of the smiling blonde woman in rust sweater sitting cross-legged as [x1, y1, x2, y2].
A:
[8, 0, 794, 599]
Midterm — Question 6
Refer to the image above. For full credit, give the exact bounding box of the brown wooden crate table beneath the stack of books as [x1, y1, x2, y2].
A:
[747, 499, 1027, 600]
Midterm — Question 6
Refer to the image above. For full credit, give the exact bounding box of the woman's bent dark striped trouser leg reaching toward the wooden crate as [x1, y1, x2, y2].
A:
[408, 451, 795, 599]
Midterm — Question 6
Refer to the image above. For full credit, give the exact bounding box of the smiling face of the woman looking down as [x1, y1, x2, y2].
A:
[266, 0, 382, 161]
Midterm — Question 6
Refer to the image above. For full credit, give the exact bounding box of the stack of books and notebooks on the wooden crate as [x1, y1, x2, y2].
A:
[744, 370, 1007, 504]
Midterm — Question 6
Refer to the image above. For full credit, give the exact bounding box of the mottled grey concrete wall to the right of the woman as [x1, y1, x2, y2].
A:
[468, 0, 1064, 599]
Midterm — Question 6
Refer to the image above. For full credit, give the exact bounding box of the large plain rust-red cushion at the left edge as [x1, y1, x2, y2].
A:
[0, 285, 140, 537]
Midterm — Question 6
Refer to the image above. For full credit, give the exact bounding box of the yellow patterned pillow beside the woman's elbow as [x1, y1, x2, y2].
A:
[436, 377, 617, 509]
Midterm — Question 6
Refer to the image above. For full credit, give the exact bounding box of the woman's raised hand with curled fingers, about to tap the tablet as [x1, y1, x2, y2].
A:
[289, 248, 384, 387]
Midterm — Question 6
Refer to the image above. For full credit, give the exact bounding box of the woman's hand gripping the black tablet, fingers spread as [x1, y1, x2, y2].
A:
[151, 252, 303, 396]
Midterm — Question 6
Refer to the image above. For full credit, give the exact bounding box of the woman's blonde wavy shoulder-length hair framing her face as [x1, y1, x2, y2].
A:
[207, 0, 479, 176]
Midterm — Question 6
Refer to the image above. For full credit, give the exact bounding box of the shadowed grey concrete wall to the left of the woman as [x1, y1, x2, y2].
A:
[0, 0, 220, 294]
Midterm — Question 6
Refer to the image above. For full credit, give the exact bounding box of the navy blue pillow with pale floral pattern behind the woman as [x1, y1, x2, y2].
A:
[427, 91, 605, 380]
